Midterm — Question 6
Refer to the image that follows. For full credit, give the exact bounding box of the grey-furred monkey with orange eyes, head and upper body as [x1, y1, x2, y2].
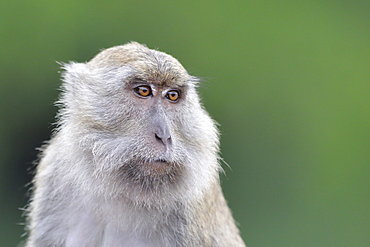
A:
[25, 42, 245, 247]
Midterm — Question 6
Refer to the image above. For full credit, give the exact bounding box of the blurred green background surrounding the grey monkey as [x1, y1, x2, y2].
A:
[0, 0, 370, 247]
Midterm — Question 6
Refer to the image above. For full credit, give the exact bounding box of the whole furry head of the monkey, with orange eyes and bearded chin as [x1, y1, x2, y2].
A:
[60, 43, 219, 205]
